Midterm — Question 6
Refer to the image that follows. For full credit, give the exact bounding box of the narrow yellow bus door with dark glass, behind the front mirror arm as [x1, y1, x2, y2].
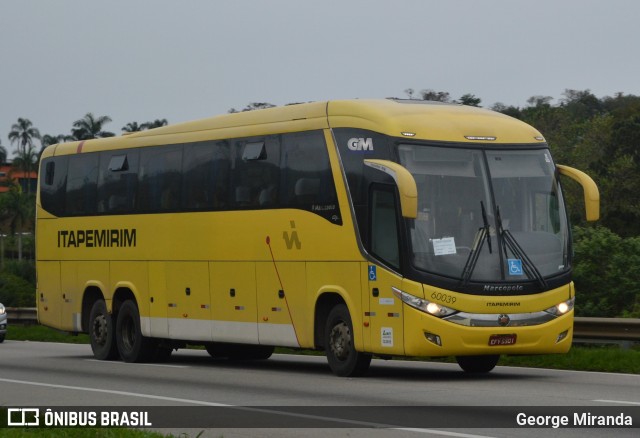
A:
[365, 184, 404, 354]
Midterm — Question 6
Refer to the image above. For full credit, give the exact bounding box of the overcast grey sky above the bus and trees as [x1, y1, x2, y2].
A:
[0, 0, 640, 153]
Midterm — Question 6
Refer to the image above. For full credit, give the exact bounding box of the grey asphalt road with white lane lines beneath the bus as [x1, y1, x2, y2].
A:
[0, 341, 640, 438]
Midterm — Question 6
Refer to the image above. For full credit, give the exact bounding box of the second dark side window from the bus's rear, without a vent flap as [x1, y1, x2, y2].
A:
[65, 153, 100, 216]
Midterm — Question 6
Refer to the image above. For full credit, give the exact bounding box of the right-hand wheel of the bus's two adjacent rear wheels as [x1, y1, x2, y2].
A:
[116, 300, 157, 362]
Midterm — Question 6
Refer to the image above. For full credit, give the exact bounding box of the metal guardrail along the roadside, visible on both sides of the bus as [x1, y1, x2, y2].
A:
[7, 307, 640, 343]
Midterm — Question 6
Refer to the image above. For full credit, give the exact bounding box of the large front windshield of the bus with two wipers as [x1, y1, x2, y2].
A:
[398, 144, 569, 287]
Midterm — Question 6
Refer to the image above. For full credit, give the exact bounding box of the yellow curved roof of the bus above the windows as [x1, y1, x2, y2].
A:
[45, 99, 544, 156]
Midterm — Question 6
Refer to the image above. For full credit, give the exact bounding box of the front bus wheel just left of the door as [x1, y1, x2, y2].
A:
[324, 304, 371, 377]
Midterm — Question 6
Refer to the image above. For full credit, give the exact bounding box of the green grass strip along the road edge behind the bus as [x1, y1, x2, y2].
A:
[6, 325, 640, 372]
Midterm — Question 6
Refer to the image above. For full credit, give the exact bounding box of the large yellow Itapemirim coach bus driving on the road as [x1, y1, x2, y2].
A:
[36, 100, 599, 376]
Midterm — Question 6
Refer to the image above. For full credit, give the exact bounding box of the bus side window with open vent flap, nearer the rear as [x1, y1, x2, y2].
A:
[98, 150, 138, 214]
